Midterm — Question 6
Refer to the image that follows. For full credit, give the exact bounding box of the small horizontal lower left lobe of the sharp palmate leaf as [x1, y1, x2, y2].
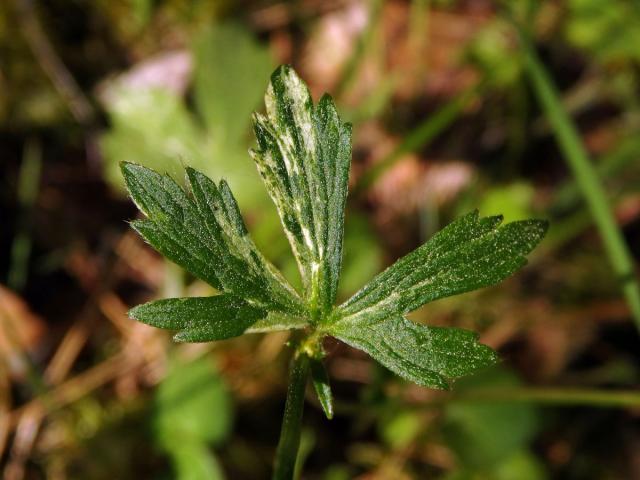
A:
[129, 294, 267, 342]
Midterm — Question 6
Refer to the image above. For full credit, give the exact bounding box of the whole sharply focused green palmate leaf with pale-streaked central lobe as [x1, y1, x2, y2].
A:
[122, 66, 546, 398]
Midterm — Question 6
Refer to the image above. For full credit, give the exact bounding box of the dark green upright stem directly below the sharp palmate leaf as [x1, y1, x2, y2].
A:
[273, 351, 309, 480]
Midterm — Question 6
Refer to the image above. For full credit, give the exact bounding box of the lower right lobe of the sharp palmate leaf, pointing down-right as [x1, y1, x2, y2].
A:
[328, 315, 497, 389]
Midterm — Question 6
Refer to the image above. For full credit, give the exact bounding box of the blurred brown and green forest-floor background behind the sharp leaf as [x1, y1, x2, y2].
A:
[0, 0, 640, 480]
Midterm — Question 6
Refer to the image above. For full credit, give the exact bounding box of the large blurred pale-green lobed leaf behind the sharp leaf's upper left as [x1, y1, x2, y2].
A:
[101, 24, 271, 207]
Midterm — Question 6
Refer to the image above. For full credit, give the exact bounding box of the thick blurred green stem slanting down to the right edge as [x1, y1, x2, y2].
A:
[520, 30, 640, 330]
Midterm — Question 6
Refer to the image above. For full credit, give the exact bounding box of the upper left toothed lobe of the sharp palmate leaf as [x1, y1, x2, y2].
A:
[122, 163, 304, 314]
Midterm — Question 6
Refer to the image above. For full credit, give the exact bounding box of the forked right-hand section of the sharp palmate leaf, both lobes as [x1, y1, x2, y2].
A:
[327, 212, 546, 388]
